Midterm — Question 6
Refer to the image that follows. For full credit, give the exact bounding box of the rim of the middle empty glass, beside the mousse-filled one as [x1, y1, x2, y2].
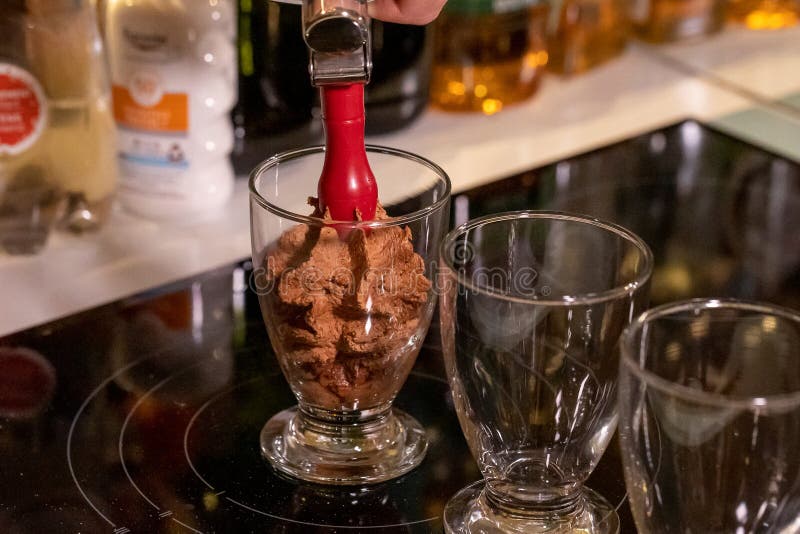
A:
[439, 210, 654, 306]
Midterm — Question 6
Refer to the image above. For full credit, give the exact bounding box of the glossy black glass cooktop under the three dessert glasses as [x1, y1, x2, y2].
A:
[0, 121, 800, 534]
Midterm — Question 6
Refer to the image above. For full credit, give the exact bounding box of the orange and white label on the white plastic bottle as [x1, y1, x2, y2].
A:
[112, 70, 189, 191]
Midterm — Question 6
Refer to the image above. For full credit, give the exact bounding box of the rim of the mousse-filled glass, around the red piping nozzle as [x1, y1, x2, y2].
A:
[248, 144, 452, 229]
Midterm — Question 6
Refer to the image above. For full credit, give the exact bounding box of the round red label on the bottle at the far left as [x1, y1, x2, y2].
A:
[0, 63, 47, 156]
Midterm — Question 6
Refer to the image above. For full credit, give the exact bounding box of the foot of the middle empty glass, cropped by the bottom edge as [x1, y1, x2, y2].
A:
[444, 480, 619, 534]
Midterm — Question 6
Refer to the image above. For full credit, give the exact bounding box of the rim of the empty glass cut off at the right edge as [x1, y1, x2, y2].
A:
[619, 298, 800, 410]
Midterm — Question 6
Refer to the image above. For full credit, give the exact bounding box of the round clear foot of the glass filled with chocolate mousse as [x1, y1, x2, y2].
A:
[261, 407, 428, 485]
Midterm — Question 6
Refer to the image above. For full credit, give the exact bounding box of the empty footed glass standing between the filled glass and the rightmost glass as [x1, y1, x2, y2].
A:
[440, 211, 653, 533]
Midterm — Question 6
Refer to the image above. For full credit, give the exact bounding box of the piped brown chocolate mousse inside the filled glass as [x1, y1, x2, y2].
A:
[264, 199, 431, 410]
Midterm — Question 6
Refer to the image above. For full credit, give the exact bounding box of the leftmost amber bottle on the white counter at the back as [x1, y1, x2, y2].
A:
[431, 5, 547, 115]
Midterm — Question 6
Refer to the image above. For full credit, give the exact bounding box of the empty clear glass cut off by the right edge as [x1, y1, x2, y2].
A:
[619, 300, 800, 534]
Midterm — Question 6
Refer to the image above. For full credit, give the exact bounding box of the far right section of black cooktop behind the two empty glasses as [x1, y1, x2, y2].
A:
[453, 121, 800, 308]
